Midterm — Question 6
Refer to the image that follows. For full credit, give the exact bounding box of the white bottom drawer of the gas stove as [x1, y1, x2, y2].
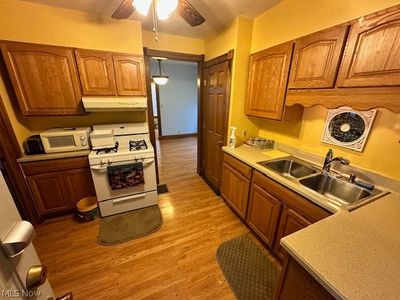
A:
[99, 192, 157, 217]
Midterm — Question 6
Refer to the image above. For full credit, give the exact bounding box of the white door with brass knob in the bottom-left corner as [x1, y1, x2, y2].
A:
[0, 171, 54, 300]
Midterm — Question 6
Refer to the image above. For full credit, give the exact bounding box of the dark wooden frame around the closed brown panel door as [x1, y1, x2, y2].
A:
[198, 49, 234, 195]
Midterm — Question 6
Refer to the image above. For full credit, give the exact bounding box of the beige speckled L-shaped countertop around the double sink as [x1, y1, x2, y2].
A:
[223, 146, 400, 299]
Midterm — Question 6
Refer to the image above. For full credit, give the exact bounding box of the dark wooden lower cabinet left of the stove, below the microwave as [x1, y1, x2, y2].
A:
[21, 157, 96, 217]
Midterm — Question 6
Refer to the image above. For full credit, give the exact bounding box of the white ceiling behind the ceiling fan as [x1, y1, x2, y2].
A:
[23, 0, 281, 38]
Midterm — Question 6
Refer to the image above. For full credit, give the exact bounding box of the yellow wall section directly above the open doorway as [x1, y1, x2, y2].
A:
[142, 31, 204, 54]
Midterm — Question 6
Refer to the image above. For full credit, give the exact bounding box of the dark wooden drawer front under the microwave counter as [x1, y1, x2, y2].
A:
[21, 156, 89, 176]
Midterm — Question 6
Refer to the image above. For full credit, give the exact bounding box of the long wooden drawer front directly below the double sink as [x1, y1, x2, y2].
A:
[253, 171, 331, 222]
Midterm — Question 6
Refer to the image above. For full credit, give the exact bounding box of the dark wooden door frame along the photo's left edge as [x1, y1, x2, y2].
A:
[0, 67, 42, 224]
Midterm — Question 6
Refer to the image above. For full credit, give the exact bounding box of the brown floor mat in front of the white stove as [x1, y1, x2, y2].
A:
[97, 205, 163, 246]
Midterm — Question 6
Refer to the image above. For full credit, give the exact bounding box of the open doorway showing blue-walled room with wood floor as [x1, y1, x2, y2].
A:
[144, 49, 204, 185]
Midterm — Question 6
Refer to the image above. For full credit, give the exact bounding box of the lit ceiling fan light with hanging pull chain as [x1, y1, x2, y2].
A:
[132, 0, 178, 42]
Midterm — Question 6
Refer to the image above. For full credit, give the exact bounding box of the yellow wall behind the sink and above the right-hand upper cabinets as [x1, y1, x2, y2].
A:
[251, 0, 400, 179]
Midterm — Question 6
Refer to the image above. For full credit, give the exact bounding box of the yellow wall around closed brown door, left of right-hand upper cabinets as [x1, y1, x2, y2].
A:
[205, 17, 258, 139]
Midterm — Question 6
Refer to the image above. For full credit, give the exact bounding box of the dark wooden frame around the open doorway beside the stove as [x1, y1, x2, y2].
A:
[143, 47, 204, 183]
